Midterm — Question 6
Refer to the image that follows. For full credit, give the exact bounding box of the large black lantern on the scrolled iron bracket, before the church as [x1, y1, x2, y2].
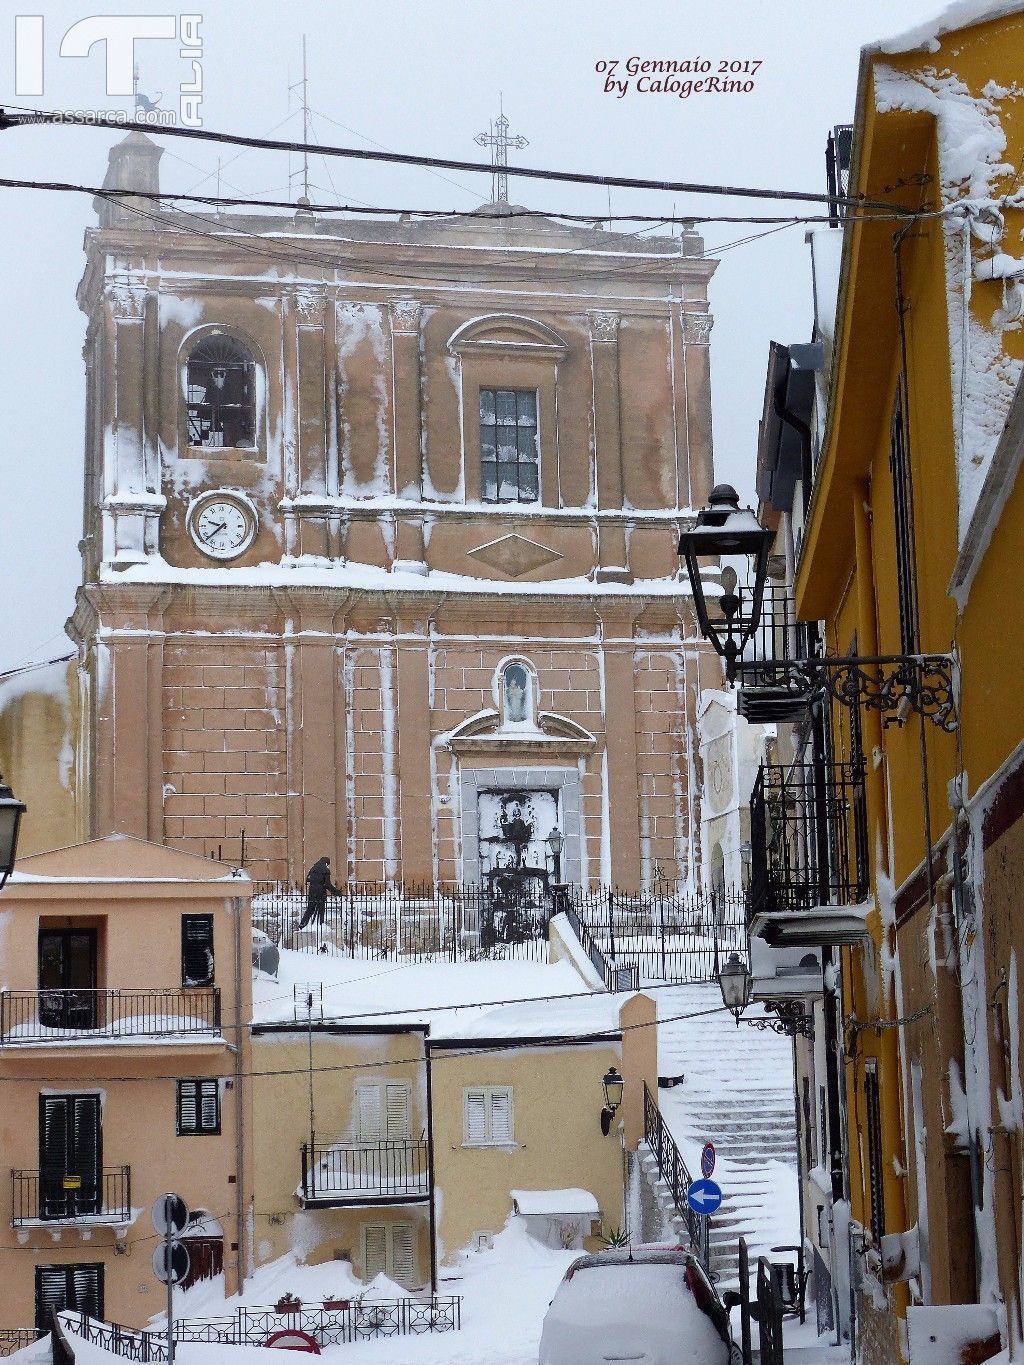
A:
[679, 483, 774, 683]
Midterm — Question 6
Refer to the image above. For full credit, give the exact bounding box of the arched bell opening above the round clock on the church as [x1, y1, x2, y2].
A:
[186, 336, 257, 450]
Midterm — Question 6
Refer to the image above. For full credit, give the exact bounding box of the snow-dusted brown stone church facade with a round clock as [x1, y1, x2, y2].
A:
[58, 134, 717, 889]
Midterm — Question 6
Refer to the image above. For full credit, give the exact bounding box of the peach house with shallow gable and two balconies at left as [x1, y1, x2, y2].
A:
[0, 835, 251, 1327]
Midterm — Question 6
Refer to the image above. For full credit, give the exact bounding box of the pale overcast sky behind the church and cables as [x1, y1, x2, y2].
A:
[0, 0, 942, 669]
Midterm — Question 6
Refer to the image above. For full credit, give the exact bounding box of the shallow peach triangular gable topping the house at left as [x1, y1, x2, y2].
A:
[8, 834, 244, 886]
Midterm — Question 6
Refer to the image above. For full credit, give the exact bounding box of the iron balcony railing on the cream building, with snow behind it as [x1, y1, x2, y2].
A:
[300, 1141, 430, 1205]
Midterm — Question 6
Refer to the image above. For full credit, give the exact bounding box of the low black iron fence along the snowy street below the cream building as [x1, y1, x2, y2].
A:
[60, 1294, 463, 1361]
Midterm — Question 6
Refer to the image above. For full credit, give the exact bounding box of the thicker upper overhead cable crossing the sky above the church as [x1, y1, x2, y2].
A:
[0, 108, 912, 216]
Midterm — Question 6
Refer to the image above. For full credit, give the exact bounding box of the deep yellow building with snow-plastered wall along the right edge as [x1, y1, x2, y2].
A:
[796, 4, 1024, 1365]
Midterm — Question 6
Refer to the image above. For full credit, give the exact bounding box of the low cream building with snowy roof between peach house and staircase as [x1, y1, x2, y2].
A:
[253, 962, 657, 1290]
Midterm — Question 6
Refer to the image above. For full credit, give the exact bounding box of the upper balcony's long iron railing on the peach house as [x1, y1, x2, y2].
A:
[0, 986, 220, 1044]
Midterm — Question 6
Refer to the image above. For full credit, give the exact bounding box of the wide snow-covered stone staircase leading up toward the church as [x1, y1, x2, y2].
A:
[640, 983, 800, 1287]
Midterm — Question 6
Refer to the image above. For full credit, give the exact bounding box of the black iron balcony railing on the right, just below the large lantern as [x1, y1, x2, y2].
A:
[750, 759, 868, 916]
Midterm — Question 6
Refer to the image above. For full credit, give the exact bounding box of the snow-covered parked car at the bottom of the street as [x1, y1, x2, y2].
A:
[541, 1246, 740, 1365]
